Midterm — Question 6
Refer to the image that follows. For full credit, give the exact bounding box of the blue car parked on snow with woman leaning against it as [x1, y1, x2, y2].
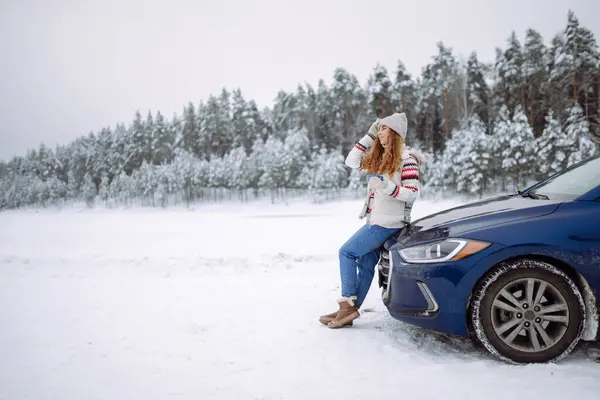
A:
[378, 156, 600, 363]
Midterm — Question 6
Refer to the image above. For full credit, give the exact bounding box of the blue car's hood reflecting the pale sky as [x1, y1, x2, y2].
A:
[397, 195, 561, 246]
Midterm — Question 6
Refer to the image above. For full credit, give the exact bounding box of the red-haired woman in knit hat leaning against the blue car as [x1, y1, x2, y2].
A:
[319, 113, 423, 328]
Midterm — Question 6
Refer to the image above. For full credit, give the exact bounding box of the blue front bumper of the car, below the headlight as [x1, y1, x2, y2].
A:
[378, 241, 497, 336]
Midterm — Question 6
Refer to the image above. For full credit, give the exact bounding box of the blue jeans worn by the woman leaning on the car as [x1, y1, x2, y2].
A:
[340, 224, 402, 308]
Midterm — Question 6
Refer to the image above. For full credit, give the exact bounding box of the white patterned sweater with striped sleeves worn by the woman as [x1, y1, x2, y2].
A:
[345, 134, 423, 228]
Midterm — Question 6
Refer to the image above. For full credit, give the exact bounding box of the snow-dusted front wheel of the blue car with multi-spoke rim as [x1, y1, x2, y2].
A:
[471, 259, 586, 364]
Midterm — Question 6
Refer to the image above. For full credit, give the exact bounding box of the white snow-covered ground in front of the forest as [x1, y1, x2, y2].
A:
[0, 201, 600, 400]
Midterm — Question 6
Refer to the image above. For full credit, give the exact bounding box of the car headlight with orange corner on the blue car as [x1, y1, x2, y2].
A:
[399, 239, 491, 264]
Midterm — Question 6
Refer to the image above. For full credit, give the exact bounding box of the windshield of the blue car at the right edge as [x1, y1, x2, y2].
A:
[531, 157, 600, 200]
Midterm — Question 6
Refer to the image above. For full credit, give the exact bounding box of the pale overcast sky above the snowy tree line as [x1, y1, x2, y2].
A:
[0, 0, 600, 160]
